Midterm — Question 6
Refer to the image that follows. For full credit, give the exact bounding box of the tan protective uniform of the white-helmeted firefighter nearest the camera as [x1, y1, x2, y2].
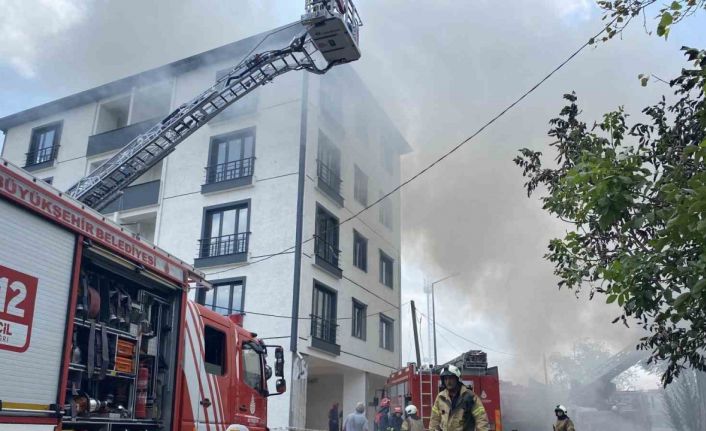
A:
[429, 385, 489, 431]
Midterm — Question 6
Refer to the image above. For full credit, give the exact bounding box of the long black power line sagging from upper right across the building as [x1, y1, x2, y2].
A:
[201, 13, 617, 274]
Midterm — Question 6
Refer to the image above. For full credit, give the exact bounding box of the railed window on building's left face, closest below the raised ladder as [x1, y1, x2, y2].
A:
[206, 129, 255, 184]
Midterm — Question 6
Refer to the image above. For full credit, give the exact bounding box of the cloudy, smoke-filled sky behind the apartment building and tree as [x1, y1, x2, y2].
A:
[0, 0, 706, 382]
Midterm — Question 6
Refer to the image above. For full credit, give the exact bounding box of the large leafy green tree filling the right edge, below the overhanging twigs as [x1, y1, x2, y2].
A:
[515, 48, 706, 385]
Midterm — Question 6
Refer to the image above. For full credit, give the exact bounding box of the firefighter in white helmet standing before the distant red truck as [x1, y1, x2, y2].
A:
[429, 365, 489, 431]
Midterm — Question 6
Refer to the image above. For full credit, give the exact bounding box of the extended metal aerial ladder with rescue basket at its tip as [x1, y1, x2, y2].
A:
[66, 0, 363, 210]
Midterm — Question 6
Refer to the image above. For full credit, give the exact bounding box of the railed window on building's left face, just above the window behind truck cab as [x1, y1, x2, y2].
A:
[199, 203, 250, 257]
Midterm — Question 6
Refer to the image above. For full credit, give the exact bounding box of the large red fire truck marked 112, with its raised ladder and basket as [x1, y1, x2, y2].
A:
[0, 0, 362, 431]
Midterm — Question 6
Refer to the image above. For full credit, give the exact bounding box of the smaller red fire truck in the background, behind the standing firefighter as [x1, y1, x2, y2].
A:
[382, 350, 502, 431]
